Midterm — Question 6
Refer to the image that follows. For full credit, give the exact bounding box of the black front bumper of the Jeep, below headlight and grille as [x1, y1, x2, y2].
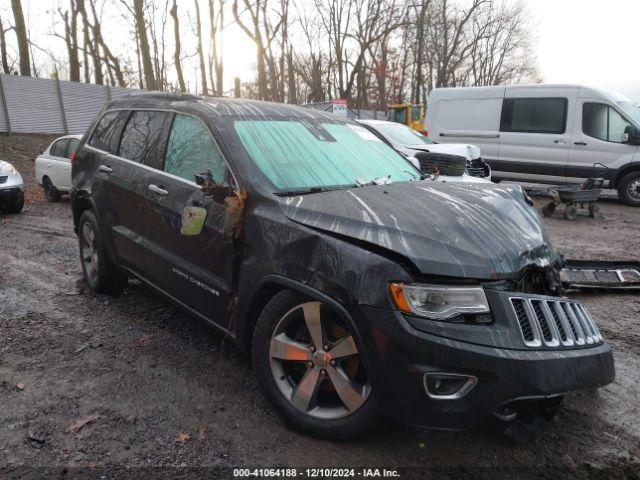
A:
[361, 298, 615, 429]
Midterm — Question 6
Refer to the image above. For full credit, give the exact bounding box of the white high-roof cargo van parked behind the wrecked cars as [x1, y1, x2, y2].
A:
[425, 85, 640, 206]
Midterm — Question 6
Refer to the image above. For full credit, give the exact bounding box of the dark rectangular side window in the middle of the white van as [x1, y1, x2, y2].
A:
[500, 98, 569, 134]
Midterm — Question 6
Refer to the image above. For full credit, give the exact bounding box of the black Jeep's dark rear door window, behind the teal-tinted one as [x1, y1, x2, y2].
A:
[118, 110, 171, 170]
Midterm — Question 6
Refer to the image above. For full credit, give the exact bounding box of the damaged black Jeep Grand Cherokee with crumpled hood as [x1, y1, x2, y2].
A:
[72, 94, 614, 438]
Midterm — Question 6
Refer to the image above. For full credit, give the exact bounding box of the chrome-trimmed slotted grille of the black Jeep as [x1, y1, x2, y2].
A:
[509, 297, 602, 348]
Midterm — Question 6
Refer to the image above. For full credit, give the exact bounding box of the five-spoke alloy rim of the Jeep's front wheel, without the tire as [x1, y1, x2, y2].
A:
[269, 302, 371, 420]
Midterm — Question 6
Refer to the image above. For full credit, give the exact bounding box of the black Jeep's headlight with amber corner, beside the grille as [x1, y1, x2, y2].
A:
[389, 283, 490, 320]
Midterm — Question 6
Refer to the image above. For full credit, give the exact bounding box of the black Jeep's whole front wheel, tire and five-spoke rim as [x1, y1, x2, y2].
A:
[252, 290, 378, 440]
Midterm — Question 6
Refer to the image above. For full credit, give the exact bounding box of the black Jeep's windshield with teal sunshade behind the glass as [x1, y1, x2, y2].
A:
[234, 119, 420, 191]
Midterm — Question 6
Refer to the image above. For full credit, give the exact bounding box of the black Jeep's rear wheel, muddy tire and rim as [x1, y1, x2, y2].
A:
[78, 210, 127, 294]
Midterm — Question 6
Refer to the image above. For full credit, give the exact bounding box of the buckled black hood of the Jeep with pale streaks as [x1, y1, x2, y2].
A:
[284, 181, 557, 279]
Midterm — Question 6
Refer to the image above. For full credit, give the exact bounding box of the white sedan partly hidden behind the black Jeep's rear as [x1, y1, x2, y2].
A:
[36, 135, 82, 202]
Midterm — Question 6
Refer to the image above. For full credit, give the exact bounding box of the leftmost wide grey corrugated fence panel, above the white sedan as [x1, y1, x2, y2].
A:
[2, 75, 64, 133]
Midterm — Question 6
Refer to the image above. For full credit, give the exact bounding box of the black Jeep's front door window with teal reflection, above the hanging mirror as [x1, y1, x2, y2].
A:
[164, 114, 229, 185]
